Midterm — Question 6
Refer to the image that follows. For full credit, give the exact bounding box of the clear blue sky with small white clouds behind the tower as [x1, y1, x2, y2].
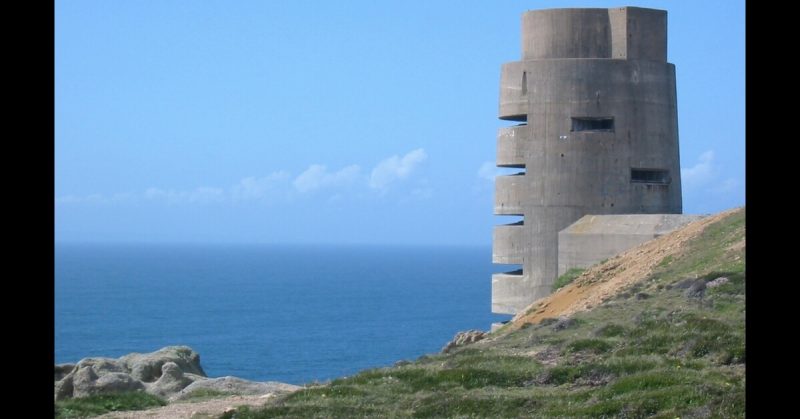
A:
[54, 0, 745, 245]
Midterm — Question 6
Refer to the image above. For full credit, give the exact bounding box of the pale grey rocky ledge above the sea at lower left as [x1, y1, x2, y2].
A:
[55, 346, 302, 401]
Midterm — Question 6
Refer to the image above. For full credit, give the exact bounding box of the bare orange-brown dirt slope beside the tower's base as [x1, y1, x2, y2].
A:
[510, 208, 744, 329]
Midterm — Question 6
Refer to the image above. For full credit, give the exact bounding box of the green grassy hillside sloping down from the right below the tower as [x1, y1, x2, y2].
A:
[225, 208, 745, 418]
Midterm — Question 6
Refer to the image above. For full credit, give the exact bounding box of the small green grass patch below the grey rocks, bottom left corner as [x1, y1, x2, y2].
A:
[55, 391, 167, 418]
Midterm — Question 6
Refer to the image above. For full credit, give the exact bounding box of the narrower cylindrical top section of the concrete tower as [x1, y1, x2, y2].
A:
[522, 7, 667, 61]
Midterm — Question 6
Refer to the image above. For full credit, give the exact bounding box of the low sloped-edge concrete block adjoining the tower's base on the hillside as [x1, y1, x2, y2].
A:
[558, 214, 703, 275]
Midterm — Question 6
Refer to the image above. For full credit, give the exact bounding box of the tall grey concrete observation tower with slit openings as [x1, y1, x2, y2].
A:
[492, 7, 682, 314]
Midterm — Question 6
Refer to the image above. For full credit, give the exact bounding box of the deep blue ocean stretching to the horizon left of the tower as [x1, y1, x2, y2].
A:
[55, 244, 509, 384]
